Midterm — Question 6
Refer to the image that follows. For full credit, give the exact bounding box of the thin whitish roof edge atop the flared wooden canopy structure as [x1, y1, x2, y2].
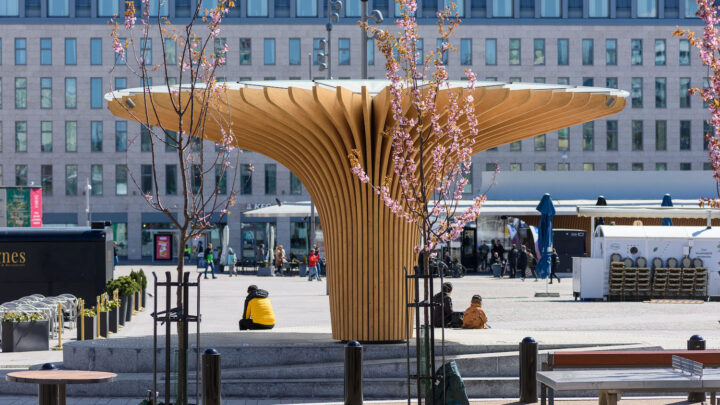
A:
[104, 80, 630, 102]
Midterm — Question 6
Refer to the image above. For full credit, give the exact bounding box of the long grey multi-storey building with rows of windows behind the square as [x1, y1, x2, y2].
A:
[0, 0, 708, 259]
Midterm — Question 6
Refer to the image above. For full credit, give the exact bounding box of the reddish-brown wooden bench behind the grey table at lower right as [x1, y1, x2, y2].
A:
[540, 350, 720, 405]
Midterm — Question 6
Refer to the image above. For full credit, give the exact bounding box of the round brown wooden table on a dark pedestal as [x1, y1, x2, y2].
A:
[5, 370, 117, 405]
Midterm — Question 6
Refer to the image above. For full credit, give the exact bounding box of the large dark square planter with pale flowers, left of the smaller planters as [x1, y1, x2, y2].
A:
[2, 312, 50, 352]
